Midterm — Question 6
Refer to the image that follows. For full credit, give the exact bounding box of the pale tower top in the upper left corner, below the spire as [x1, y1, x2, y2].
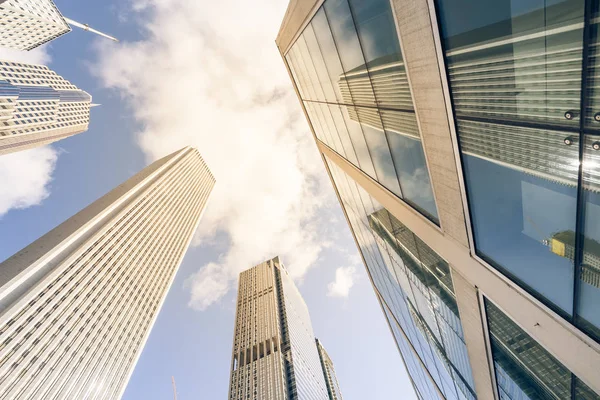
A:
[0, 0, 71, 50]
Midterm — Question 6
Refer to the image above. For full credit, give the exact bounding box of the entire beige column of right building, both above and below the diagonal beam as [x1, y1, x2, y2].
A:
[391, 0, 495, 400]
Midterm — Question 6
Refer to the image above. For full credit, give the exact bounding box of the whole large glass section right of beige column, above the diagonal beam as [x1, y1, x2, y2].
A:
[436, 0, 600, 340]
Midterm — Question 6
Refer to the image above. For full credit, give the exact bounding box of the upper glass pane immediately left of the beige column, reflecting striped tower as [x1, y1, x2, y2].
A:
[348, 0, 413, 109]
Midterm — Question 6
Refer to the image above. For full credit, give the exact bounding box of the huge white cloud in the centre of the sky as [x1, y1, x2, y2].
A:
[93, 0, 335, 309]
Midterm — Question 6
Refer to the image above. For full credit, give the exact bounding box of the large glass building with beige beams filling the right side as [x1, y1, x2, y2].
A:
[276, 0, 600, 400]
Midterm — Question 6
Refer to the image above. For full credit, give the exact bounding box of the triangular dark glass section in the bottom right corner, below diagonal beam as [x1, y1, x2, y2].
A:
[485, 300, 600, 400]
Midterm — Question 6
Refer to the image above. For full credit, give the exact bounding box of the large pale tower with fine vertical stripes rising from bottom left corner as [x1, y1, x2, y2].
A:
[0, 147, 214, 399]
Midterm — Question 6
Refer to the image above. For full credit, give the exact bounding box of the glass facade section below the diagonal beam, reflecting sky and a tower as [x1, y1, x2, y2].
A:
[327, 159, 476, 399]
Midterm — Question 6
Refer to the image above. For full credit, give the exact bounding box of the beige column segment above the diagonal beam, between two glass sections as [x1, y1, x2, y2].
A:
[391, 0, 469, 247]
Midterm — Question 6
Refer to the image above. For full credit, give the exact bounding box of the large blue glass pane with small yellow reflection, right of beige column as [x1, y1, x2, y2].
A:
[457, 120, 578, 313]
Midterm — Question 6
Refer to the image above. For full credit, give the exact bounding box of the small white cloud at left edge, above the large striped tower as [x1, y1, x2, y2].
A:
[0, 146, 57, 216]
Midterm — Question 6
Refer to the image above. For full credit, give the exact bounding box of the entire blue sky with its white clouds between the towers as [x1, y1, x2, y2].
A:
[0, 0, 414, 399]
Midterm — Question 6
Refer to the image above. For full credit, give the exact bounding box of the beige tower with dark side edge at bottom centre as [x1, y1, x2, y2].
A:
[229, 257, 329, 400]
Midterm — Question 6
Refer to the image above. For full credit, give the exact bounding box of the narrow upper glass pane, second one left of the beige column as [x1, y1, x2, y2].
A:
[323, 0, 375, 105]
